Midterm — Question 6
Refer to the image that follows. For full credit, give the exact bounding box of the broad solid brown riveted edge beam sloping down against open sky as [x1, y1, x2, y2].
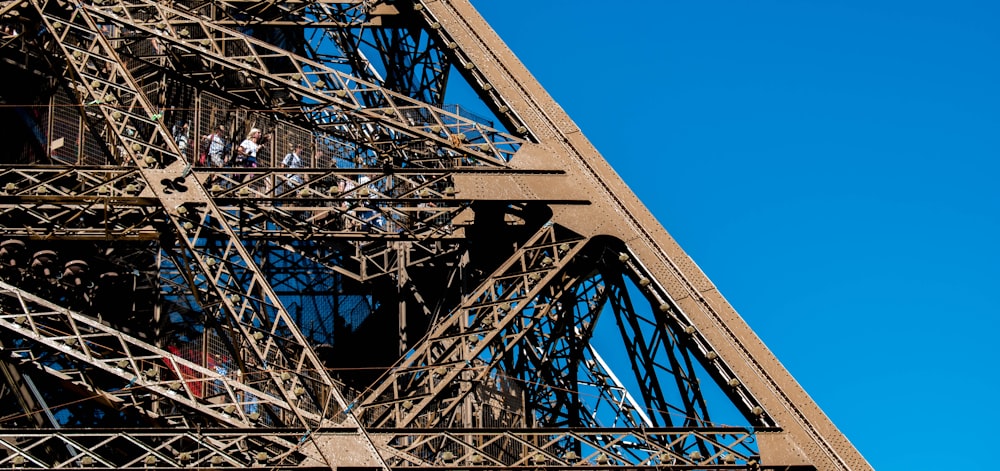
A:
[419, 0, 871, 469]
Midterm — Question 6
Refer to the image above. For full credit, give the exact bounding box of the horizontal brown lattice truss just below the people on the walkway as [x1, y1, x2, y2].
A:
[0, 167, 583, 298]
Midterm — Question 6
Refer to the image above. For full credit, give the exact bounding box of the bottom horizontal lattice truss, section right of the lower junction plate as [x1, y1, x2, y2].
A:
[373, 427, 760, 470]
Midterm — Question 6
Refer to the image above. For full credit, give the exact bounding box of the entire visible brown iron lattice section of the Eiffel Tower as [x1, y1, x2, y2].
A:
[0, 0, 871, 470]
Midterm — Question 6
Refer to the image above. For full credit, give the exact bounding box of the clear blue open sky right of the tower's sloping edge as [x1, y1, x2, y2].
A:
[473, 0, 1000, 471]
